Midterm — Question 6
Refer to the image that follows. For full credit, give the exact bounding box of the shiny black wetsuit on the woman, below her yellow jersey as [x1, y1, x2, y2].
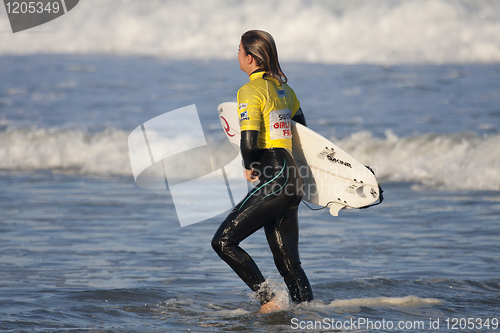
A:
[212, 123, 313, 304]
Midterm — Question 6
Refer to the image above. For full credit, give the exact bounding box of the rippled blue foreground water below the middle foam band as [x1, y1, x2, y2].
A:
[0, 172, 500, 332]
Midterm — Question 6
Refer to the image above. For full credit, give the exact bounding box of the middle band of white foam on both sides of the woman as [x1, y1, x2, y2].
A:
[0, 128, 500, 190]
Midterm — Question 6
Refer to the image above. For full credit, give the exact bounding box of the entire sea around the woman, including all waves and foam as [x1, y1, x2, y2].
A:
[0, 0, 500, 332]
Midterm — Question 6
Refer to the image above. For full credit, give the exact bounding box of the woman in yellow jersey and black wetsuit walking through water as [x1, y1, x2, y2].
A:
[212, 30, 313, 313]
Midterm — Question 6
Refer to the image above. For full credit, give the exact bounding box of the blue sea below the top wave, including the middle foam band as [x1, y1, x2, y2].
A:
[0, 51, 500, 332]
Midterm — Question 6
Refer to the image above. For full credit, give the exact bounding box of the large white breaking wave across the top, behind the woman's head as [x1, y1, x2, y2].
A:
[0, 0, 500, 64]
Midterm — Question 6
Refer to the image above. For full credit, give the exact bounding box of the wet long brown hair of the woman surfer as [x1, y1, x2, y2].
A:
[241, 30, 288, 84]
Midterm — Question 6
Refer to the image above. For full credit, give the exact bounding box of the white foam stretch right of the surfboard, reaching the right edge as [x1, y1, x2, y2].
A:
[336, 131, 500, 190]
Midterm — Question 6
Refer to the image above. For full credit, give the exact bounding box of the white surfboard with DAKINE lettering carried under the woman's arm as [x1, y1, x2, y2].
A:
[218, 102, 380, 216]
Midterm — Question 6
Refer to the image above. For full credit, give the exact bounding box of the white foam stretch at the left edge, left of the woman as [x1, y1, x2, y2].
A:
[0, 128, 132, 175]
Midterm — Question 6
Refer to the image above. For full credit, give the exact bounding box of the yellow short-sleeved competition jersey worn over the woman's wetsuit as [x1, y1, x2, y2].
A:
[238, 72, 300, 151]
